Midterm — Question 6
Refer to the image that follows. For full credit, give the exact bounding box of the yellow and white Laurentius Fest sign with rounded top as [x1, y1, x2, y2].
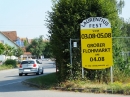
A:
[81, 17, 113, 69]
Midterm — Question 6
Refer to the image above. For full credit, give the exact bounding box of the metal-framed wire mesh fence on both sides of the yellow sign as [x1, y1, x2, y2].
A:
[70, 37, 130, 82]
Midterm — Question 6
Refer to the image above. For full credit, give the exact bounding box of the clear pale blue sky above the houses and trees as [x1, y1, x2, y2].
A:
[0, 0, 130, 39]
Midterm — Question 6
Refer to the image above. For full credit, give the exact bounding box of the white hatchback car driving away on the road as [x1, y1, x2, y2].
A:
[19, 59, 44, 76]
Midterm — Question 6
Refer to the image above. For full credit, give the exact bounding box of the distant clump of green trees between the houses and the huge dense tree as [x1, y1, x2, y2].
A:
[26, 36, 53, 59]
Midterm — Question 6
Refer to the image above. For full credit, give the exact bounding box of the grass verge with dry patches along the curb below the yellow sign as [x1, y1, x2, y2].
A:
[26, 73, 130, 95]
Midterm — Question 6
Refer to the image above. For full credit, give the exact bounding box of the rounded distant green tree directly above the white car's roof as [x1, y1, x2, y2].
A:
[27, 36, 45, 58]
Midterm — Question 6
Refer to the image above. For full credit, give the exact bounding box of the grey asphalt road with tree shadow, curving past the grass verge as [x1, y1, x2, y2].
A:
[0, 60, 130, 97]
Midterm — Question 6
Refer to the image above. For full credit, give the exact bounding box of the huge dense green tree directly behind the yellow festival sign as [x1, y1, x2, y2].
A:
[46, 0, 123, 79]
